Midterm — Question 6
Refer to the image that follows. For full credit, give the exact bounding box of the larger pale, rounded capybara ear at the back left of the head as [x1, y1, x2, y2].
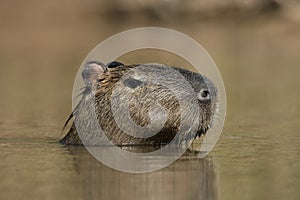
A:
[81, 61, 107, 85]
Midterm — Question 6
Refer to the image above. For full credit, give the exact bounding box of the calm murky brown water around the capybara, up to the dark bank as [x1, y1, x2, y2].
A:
[0, 2, 300, 200]
